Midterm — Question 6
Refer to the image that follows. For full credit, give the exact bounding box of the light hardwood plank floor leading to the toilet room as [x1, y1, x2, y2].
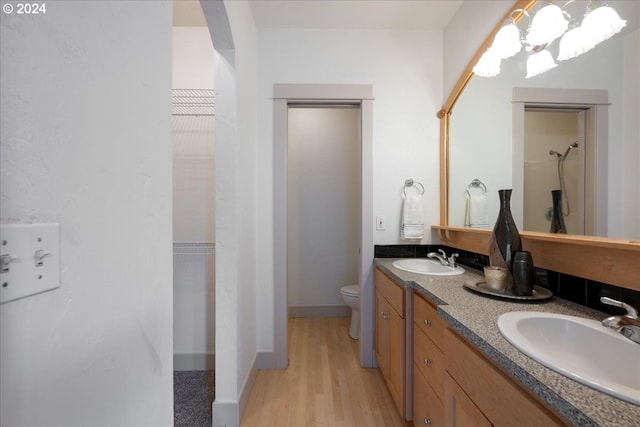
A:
[240, 317, 412, 427]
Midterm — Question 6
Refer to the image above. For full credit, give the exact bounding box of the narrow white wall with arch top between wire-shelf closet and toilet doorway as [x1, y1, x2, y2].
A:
[201, 1, 262, 426]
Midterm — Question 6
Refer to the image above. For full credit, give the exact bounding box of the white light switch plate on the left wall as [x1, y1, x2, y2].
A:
[0, 224, 60, 304]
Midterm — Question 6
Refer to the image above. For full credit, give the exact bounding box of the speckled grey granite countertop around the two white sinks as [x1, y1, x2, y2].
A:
[375, 258, 640, 426]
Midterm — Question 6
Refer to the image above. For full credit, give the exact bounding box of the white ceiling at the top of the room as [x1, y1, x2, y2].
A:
[173, 0, 463, 30]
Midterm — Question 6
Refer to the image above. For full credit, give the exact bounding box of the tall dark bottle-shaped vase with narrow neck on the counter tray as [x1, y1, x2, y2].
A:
[489, 189, 522, 292]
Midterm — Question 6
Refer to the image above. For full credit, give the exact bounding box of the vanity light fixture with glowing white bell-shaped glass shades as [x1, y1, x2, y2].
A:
[473, 0, 626, 78]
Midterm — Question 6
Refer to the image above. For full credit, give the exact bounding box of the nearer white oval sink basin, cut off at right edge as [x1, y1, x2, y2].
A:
[498, 311, 640, 405]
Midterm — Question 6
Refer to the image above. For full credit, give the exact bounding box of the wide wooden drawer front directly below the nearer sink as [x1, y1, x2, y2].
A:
[444, 329, 566, 426]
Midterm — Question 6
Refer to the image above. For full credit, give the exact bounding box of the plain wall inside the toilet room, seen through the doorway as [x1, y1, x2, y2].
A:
[287, 107, 361, 310]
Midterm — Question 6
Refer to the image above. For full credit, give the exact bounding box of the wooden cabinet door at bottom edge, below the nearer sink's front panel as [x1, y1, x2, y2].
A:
[444, 374, 491, 427]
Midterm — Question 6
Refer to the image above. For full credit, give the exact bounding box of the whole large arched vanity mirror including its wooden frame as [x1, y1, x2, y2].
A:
[434, 0, 640, 290]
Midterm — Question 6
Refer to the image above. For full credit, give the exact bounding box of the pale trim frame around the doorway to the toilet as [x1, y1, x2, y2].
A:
[270, 84, 376, 369]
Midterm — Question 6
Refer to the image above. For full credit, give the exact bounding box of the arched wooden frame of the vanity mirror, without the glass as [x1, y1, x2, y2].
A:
[433, 0, 640, 290]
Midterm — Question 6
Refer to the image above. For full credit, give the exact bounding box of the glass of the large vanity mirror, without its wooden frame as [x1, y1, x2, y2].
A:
[448, 0, 640, 240]
